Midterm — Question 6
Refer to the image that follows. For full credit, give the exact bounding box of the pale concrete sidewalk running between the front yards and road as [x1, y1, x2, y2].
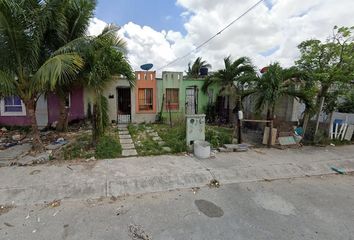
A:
[0, 146, 354, 205]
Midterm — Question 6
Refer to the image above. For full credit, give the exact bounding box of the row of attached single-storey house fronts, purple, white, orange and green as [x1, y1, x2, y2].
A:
[0, 71, 303, 127]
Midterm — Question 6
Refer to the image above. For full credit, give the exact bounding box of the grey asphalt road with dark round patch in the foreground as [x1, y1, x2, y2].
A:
[0, 175, 354, 240]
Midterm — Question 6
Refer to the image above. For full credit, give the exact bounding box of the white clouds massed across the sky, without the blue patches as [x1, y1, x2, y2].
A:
[89, 0, 354, 75]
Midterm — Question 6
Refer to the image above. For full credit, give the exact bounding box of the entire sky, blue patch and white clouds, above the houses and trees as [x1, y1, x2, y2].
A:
[89, 0, 354, 75]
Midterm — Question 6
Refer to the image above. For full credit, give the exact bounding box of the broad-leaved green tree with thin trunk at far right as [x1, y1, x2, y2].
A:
[296, 26, 354, 137]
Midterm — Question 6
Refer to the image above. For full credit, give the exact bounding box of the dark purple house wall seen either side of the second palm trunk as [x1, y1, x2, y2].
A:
[47, 87, 85, 123]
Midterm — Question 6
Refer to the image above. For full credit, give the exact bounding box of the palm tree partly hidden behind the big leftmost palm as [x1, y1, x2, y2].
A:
[53, 0, 96, 131]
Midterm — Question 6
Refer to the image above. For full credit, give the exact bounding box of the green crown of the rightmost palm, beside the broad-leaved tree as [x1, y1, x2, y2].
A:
[255, 63, 311, 120]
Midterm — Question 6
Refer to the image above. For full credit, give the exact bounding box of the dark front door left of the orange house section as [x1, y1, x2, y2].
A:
[117, 87, 131, 123]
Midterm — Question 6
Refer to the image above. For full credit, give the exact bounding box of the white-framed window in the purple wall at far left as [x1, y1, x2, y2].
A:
[1, 96, 26, 116]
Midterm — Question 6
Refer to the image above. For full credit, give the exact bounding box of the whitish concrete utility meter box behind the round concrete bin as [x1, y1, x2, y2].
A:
[186, 114, 205, 150]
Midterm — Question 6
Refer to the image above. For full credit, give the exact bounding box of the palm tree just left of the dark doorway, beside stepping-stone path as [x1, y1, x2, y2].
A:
[80, 25, 135, 145]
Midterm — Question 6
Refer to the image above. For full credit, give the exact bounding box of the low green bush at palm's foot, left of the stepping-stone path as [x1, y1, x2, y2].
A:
[95, 135, 122, 159]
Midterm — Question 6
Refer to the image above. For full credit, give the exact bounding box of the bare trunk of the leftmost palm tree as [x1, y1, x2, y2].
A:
[25, 99, 44, 152]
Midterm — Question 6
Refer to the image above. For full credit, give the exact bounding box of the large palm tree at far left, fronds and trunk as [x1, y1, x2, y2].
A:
[0, 0, 83, 151]
